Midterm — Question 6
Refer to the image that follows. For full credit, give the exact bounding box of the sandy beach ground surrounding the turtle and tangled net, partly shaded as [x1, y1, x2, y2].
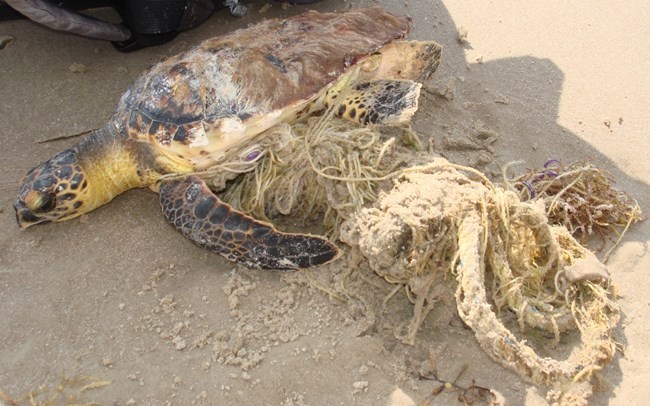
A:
[0, 0, 650, 405]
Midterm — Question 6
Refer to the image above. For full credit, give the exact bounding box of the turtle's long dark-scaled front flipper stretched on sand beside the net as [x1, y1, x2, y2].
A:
[160, 176, 339, 270]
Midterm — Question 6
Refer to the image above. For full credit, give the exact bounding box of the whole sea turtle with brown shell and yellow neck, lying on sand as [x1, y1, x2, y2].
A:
[14, 8, 440, 269]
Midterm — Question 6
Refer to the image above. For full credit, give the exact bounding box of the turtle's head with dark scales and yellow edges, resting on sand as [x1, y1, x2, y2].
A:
[14, 149, 93, 228]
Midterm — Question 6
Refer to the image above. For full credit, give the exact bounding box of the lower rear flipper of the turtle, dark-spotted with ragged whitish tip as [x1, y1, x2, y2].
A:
[325, 79, 422, 125]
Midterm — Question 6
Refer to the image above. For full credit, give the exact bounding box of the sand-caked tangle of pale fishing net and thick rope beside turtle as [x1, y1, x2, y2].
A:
[205, 104, 640, 403]
